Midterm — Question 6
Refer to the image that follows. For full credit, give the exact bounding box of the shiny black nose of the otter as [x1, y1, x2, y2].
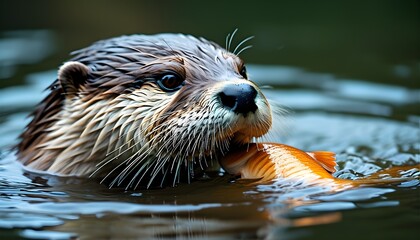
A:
[219, 83, 258, 115]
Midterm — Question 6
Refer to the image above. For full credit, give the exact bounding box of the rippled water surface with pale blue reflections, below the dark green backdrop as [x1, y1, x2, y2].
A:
[0, 33, 420, 239]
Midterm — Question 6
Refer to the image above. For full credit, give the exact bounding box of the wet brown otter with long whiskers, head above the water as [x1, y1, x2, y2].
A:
[17, 34, 272, 188]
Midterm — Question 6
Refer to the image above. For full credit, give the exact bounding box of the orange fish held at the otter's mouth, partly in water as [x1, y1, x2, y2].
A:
[220, 143, 413, 190]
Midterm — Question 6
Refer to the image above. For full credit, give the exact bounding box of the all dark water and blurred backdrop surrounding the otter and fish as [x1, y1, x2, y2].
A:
[0, 1, 420, 239]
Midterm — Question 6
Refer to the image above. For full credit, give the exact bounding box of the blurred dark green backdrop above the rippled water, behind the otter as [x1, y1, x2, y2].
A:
[0, 0, 420, 88]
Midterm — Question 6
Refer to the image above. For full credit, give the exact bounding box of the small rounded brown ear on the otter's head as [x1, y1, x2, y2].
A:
[58, 61, 89, 96]
